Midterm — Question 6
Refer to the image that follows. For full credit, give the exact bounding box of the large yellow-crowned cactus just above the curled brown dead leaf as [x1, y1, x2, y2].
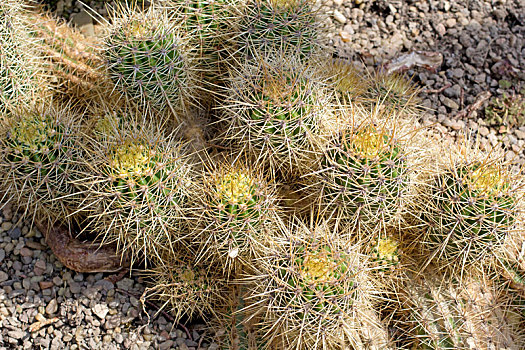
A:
[81, 122, 192, 263]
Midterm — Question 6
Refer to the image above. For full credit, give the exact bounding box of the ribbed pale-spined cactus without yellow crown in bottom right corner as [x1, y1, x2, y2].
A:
[400, 273, 521, 350]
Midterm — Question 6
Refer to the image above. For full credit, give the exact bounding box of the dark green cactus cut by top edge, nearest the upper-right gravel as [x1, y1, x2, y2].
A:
[235, 0, 321, 59]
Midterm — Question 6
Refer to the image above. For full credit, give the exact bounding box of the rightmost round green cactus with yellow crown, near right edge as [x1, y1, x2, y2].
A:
[422, 162, 518, 264]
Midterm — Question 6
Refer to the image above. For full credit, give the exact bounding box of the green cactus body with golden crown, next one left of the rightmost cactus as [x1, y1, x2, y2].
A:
[319, 124, 410, 225]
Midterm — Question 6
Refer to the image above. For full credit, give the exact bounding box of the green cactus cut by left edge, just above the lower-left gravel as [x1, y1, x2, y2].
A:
[0, 109, 81, 221]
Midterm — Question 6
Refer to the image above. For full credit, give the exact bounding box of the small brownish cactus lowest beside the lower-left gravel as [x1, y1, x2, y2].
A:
[144, 253, 227, 322]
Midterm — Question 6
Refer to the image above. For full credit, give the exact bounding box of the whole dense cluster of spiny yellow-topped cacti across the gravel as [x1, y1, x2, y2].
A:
[0, 0, 525, 350]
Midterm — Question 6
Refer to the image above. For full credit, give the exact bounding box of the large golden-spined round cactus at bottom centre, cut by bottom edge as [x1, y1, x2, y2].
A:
[248, 217, 371, 349]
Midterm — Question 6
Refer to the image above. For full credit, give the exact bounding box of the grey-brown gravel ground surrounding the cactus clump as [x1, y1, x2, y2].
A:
[0, 0, 525, 350]
